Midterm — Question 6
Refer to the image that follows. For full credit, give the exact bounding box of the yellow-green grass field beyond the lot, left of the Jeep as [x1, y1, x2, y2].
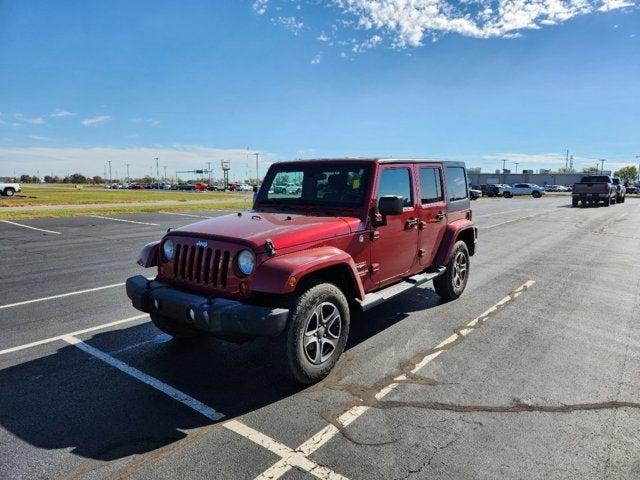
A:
[0, 185, 252, 220]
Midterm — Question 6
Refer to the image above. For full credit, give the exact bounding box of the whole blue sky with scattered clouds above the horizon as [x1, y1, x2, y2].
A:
[0, 0, 640, 177]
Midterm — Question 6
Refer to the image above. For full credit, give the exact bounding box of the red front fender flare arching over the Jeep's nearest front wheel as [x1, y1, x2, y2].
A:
[251, 246, 365, 299]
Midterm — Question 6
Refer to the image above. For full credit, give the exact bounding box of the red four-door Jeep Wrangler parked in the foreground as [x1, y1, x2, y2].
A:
[127, 159, 477, 384]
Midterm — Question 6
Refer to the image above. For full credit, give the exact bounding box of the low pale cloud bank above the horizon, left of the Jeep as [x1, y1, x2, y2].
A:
[0, 145, 273, 179]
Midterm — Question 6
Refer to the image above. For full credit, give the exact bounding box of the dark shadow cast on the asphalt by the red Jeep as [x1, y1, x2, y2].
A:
[0, 288, 440, 464]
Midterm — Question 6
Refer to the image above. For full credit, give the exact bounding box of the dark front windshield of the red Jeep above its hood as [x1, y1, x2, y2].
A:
[257, 162, 371, 207]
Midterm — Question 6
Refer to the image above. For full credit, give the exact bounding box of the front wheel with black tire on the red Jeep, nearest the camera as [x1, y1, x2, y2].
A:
[271, 281, 350, 385]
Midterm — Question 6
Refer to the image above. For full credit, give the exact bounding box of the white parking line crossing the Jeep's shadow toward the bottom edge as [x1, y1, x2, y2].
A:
[61, 335, 347, 480]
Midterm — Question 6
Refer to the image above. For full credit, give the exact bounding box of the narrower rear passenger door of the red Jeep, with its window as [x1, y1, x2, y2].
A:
[418, 164, 447, 267]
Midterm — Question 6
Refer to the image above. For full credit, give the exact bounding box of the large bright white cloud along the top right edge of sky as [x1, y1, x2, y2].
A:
[333, 0, 636, 48]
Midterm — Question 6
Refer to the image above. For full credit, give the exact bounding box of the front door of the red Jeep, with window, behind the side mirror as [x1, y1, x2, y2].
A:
[371, 164, 418, 287]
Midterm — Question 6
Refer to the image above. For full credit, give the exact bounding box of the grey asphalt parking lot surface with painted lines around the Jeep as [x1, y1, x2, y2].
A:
[0, 196, 640, 480]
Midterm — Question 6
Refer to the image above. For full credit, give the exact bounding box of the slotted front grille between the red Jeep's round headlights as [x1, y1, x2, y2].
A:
[173, 243, 231, 288]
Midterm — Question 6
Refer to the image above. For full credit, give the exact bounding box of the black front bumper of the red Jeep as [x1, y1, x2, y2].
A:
[127, 275, 289, 339]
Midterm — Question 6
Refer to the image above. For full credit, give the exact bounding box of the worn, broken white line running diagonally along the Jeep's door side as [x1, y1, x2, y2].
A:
[256, 280, 536, 480]
